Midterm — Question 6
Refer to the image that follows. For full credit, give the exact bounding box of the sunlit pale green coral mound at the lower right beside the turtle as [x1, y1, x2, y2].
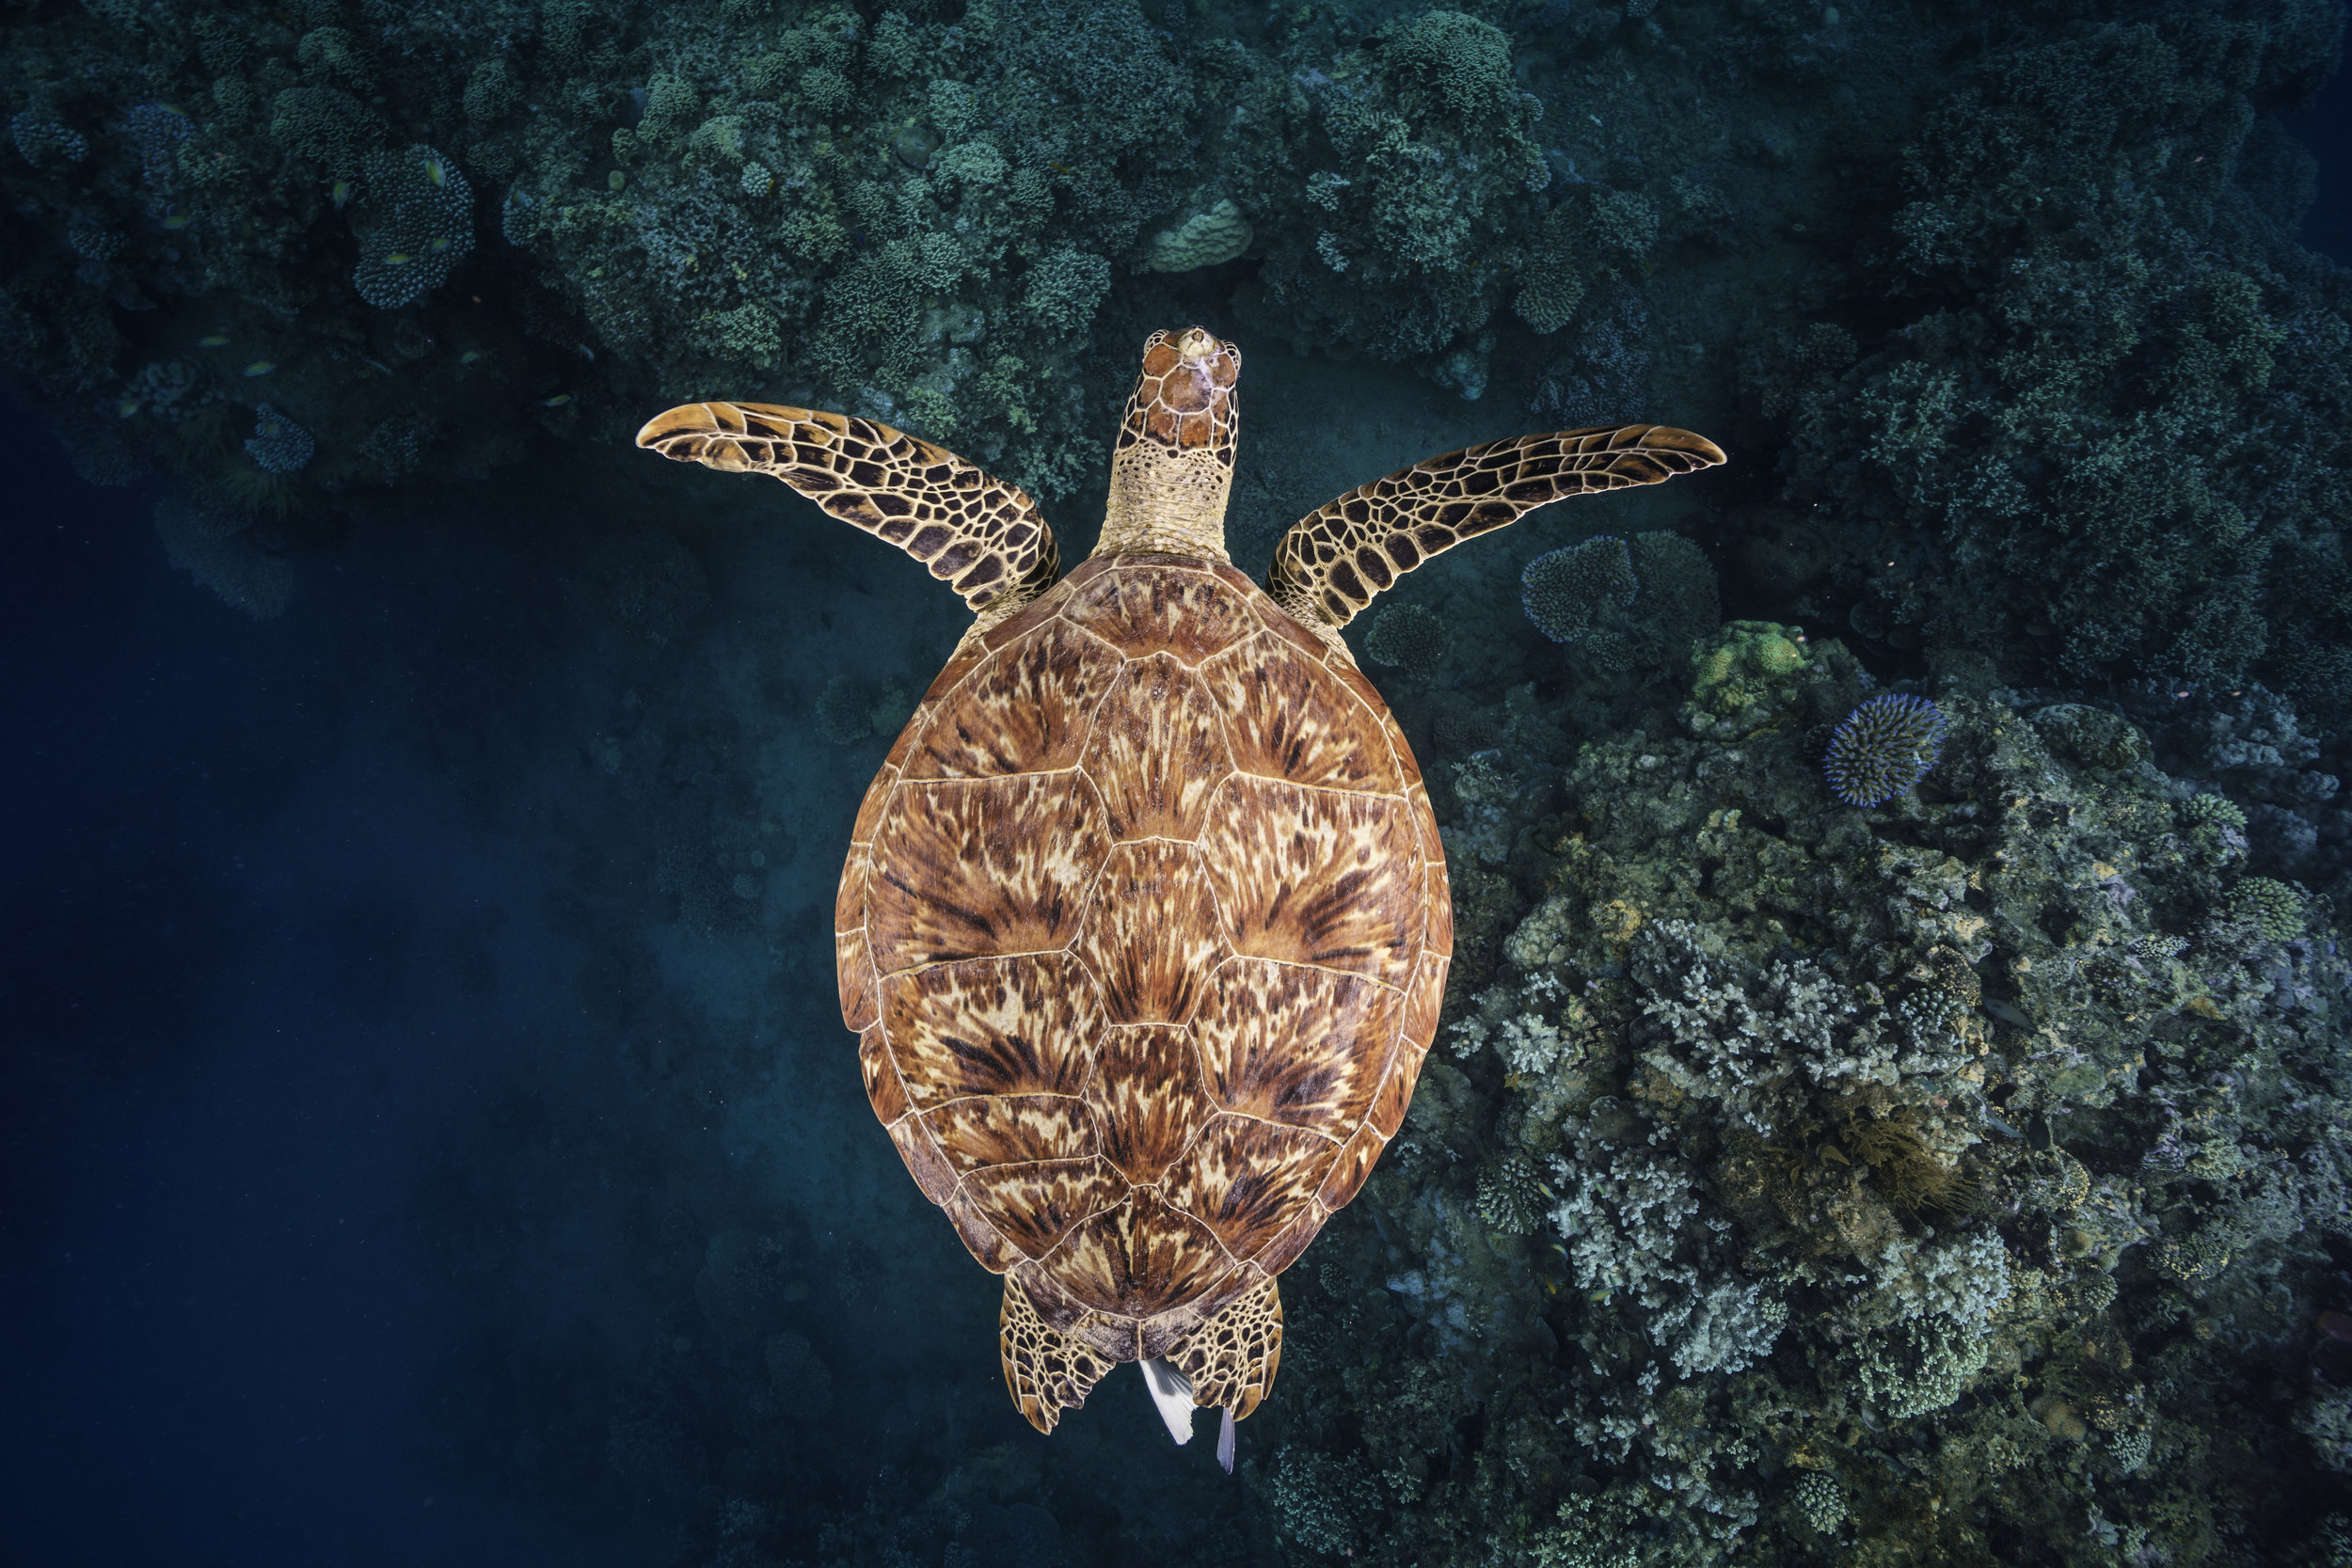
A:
[1287, 623, 2352, 1563]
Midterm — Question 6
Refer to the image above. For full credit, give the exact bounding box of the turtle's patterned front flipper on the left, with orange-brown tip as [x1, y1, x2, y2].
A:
[638, 402, 1061, 623]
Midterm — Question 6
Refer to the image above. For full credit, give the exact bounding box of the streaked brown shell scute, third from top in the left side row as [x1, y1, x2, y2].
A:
[882, 952, 1104, 1110]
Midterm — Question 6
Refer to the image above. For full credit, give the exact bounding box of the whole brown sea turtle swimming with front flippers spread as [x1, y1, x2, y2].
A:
[638, 326, 1724, 1469]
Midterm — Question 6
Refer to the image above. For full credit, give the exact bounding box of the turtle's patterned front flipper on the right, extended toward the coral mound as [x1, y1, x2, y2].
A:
[1265, 425, 1724, 632]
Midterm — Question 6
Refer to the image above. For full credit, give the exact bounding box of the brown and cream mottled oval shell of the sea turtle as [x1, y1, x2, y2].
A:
[835, 555, 1454, 1361]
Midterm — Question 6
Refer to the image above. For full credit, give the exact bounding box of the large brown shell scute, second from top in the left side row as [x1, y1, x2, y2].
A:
[866, 773, 1110, 974]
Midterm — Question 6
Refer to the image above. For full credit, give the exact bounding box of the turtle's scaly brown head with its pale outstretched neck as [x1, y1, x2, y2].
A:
[1094, 326, 1242, 562]
